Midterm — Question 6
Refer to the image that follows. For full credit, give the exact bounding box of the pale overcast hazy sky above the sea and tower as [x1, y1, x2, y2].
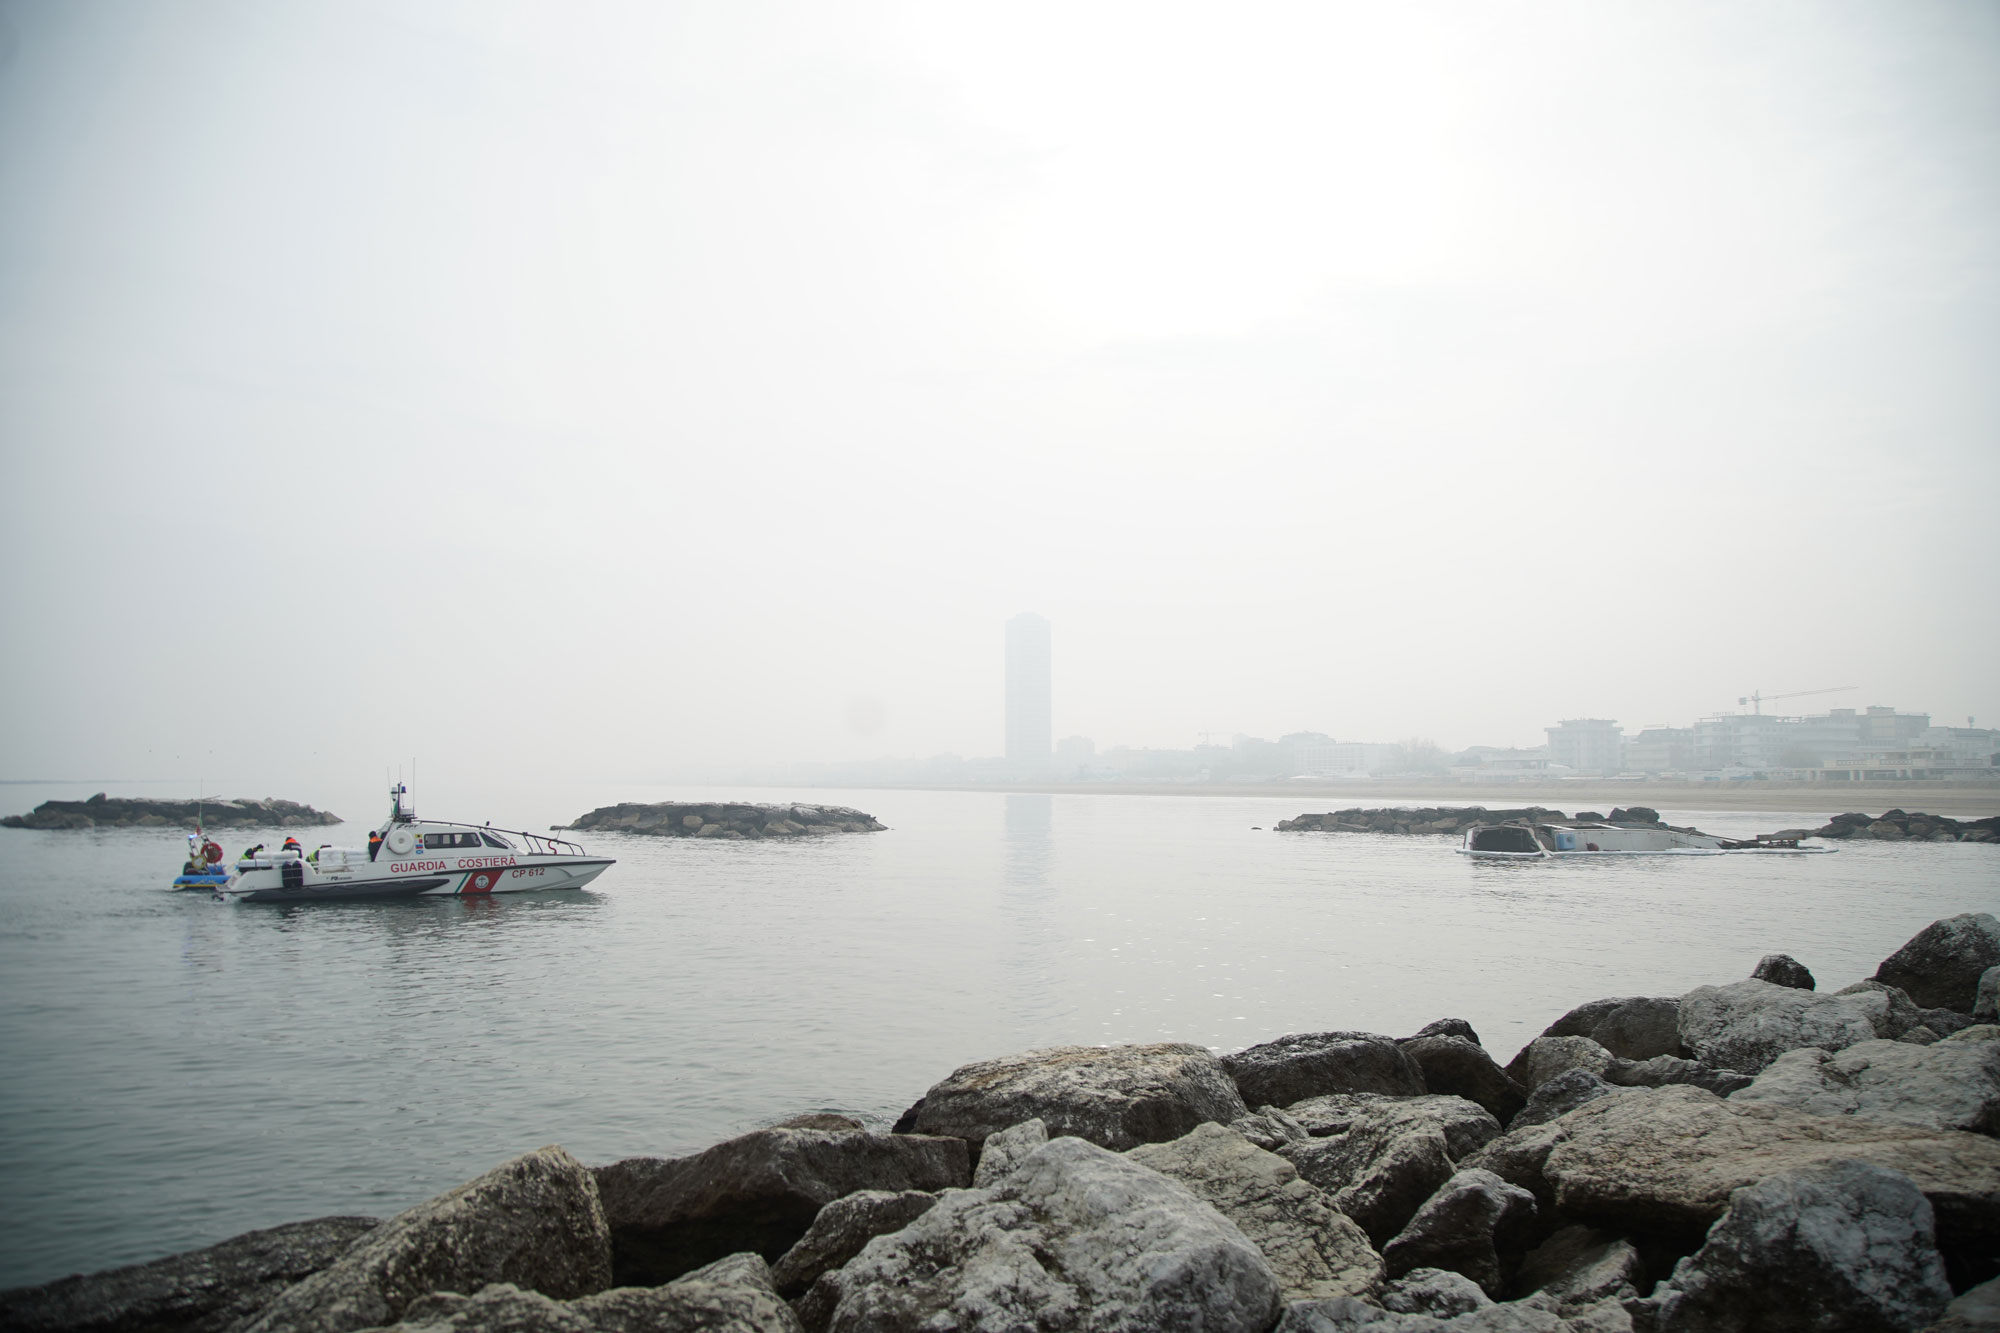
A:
[0, 0, 2000, 795]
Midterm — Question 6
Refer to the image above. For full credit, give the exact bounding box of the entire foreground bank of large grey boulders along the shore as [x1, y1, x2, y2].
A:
[11, 913, 2000, 1333]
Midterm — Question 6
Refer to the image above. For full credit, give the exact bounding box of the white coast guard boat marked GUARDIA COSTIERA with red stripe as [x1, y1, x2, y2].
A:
[216, 783, 614, 903]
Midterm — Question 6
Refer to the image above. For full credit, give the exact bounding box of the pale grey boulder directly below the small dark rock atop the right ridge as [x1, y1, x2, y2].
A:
[1680, 981, 1888, 1075]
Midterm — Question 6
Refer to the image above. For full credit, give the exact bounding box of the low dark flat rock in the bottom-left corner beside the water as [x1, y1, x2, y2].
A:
[0, 1217, 380, 1333]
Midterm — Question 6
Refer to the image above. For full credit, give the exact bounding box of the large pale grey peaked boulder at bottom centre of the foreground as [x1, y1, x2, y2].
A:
[814, 1137, 1282, 1333]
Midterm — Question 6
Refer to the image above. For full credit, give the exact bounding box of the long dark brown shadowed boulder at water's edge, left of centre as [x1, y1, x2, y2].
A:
[596, 1129, 972, 1287]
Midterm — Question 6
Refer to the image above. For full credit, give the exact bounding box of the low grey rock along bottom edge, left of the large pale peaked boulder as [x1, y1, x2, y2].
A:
[356, 1255, 800, 1333]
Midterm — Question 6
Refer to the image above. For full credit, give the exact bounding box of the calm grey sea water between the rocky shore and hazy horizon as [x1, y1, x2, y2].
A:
[0, 789, 2000, 1287]
